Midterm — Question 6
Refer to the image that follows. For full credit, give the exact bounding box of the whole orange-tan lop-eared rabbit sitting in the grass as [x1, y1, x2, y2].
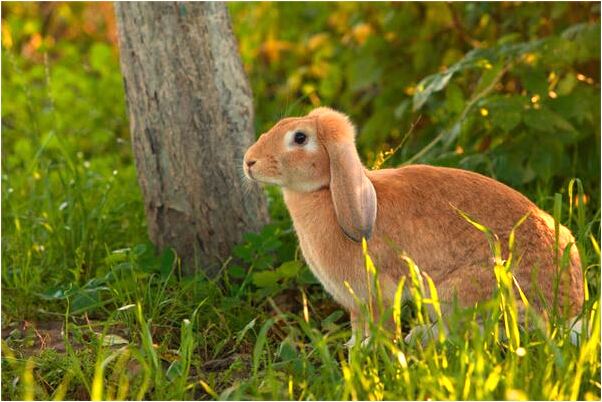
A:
[243, 107, 584, 345]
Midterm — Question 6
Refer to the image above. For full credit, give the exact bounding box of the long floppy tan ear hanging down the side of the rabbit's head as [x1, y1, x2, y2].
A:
[310, 108, 377, 242]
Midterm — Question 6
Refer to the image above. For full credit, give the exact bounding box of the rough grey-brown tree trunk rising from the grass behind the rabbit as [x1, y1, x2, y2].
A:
[115, 2, 267, 274]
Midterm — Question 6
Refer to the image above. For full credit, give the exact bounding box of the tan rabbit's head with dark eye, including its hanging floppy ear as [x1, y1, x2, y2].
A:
[243, 107, 376, 241]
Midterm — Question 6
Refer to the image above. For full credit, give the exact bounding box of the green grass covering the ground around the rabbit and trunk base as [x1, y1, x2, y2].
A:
[2, 123, 600, 400]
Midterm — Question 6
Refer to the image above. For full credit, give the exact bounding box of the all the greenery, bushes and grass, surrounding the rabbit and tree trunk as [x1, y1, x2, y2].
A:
[2, 2, 600, 399]
